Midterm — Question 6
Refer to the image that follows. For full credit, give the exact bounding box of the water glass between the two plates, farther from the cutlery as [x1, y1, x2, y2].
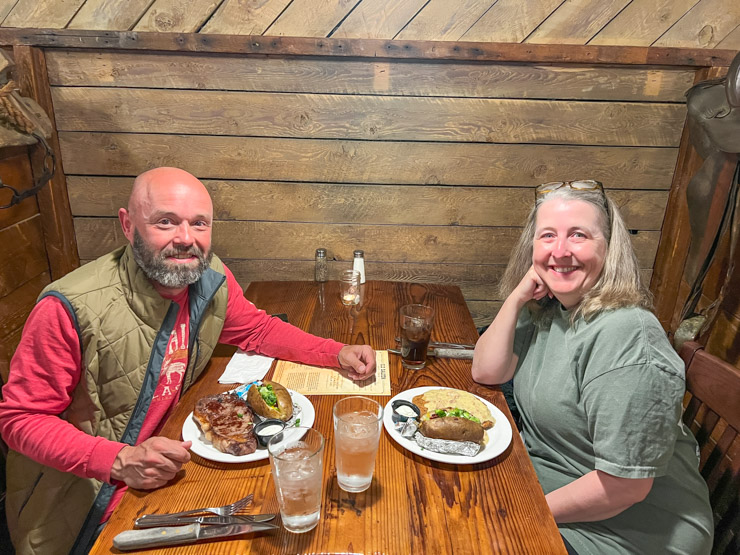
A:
[334, 397, 383, 493]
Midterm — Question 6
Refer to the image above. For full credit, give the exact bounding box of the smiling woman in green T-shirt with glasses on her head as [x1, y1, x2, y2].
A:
[472, 180, 713, 555]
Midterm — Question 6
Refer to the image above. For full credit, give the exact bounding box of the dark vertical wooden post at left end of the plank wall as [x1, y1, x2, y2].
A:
[13, 45, 80, 279]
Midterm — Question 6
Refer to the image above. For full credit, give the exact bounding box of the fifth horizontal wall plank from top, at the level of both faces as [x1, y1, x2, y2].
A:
[75, 218, 660, 268]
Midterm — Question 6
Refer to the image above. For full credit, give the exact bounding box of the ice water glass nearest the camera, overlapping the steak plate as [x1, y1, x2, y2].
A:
[267, 427, 324, 534]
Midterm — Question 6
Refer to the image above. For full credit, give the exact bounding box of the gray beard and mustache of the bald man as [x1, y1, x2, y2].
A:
[132, 230, 213, 289]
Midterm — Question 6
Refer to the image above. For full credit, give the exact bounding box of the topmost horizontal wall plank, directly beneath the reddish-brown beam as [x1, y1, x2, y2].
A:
[42, 50, 694, 103]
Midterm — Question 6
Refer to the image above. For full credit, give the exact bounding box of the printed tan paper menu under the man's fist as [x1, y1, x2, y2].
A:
[272, 351, 391, 395]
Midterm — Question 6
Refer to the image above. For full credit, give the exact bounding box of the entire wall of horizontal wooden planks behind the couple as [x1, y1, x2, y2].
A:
[46, 49, 694, 325]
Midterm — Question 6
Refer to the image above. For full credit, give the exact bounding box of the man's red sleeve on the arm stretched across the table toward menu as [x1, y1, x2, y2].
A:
[219, 267, 344, 368]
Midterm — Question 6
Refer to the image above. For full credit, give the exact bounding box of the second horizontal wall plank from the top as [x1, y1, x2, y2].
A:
[53, 87, 686, 147]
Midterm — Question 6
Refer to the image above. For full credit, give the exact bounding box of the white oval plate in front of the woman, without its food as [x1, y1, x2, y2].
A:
[383, 387, 512, 464]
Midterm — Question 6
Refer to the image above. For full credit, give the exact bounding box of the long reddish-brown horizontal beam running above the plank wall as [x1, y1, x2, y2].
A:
[0, 28, 736, 67]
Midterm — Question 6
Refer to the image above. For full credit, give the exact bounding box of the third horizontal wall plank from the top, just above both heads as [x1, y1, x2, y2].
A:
[59, 132, 677, 189]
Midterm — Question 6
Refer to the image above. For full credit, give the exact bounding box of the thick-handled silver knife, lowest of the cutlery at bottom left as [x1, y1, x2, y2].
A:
[113, 522, 277, 551]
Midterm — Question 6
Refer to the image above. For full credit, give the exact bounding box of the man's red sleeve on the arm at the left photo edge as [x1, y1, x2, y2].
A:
[0, 297, 125, 482]
